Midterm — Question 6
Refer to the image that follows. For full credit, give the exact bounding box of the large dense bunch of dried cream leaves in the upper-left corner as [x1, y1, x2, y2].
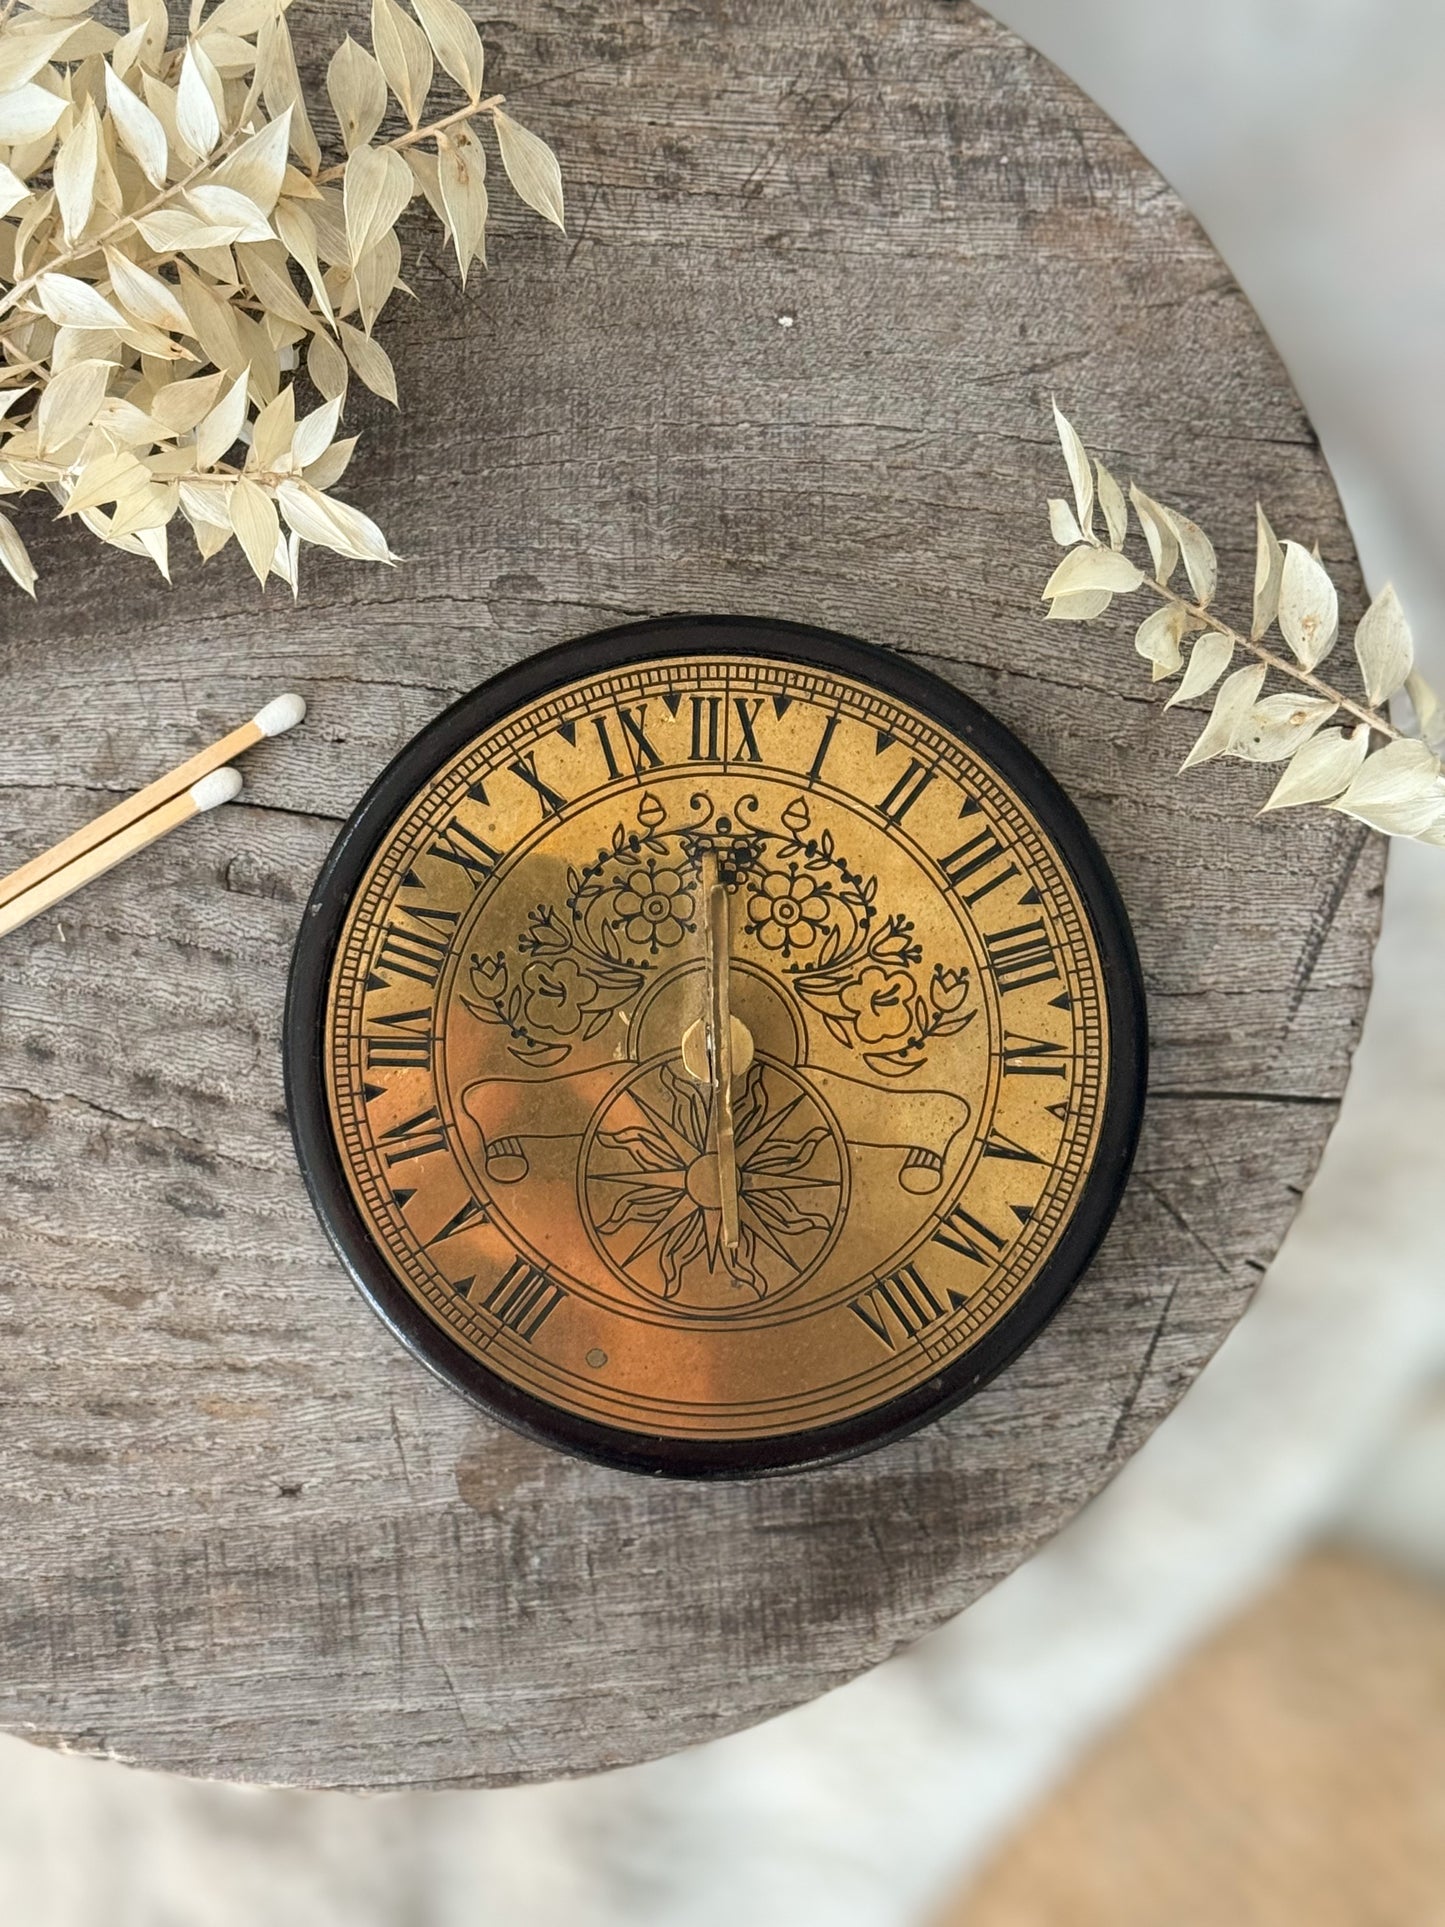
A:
[0, 0, 563, 594]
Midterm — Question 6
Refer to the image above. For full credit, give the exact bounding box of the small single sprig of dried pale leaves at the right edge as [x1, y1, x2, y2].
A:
[1044, 405, 1445, 846]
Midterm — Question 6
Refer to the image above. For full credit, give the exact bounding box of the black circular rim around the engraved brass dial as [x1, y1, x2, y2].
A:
[283, 615, 1148, 1478]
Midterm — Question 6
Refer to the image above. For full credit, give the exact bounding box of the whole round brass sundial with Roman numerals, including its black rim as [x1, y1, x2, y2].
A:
[287, 619, 1144, 1476]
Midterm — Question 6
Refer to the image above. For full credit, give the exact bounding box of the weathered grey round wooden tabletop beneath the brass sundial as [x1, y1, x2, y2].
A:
[0, 0, 1383, 1786]
